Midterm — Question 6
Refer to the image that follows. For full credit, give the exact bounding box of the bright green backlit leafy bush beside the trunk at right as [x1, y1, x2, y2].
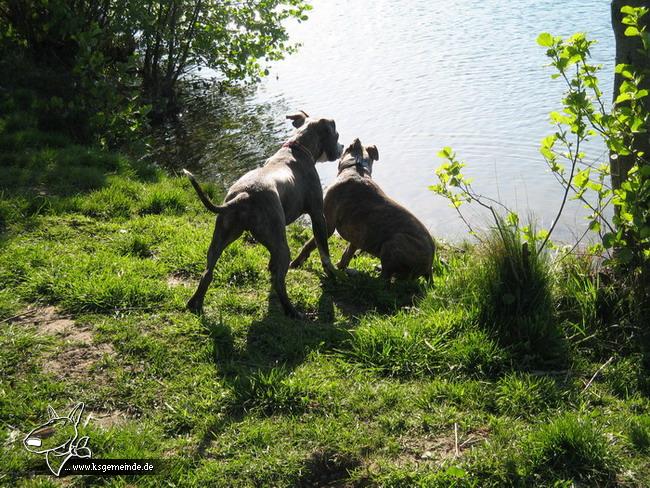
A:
[537, 6, 650, 272]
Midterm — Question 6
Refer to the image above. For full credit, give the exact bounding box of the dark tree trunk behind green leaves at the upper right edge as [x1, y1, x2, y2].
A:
[610, 0, 650, 189]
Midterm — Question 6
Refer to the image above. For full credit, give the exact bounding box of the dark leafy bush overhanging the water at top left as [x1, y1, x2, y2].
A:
[0, 0, 311, 138]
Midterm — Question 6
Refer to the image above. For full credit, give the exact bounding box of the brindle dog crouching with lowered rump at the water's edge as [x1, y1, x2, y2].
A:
[291, 139, 435, 280]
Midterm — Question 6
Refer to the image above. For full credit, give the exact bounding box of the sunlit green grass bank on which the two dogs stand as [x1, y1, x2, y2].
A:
[0, 89, 650, 487]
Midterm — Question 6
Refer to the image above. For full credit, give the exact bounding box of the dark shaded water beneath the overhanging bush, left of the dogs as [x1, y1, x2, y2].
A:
[150, 80, 290, 189]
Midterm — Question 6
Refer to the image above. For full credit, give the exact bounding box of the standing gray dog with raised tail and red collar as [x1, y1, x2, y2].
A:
[184, 112, 343, 317]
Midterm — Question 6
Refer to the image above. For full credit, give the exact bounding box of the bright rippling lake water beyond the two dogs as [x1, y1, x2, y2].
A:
[256, 0, 615, 241]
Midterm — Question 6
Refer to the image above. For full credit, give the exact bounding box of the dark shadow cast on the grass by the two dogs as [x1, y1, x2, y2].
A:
[192, 273, 425, 460]
